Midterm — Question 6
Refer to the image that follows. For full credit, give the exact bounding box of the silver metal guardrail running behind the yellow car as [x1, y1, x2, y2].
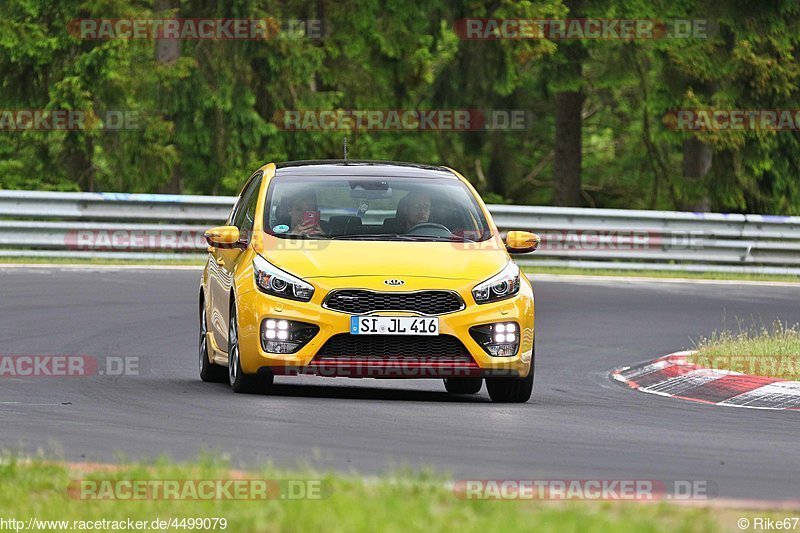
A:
[0, 190, 800, 275]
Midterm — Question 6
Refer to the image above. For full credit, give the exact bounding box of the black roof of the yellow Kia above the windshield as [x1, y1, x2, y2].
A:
[275, 159, 458, 179]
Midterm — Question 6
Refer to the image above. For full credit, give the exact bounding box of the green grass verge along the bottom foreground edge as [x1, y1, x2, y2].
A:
[0, 458, 740, 533]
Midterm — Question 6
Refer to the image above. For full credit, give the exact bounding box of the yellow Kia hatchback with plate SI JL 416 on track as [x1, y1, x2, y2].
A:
[199, 161, 539, 402]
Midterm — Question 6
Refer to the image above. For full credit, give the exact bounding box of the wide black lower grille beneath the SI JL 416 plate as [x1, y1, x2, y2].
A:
[316, 333, 472, 362]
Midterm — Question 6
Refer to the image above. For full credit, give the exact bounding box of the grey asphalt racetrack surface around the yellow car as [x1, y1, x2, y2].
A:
[0, 267, 800, 500]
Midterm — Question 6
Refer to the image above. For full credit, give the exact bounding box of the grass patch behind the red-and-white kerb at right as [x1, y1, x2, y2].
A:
[690, 322, 800, 380]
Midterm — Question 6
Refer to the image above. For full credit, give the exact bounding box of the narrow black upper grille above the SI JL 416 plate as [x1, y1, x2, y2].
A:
[323, 289, 464, 315]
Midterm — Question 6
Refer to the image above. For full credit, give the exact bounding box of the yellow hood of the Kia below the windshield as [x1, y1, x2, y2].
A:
[256, 233, 509, 282]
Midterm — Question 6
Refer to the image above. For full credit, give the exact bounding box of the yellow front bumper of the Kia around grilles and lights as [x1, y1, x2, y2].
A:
[237, 277, 534, 378]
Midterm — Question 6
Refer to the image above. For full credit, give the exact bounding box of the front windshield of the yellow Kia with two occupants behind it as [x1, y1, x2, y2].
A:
[264, 176, 491, 242]
